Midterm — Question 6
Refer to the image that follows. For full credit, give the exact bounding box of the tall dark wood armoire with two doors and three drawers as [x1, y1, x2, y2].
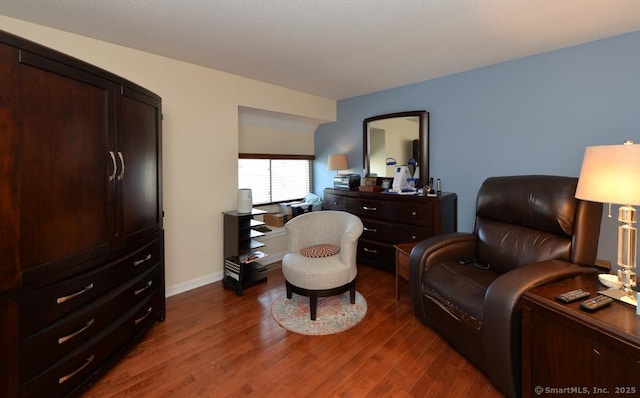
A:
[0, 31, 165, 397]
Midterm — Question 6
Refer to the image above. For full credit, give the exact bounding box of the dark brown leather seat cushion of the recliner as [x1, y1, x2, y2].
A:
[422, 261, 500, 329]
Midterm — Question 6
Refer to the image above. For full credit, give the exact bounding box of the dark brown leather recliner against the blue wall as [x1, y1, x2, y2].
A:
[409, 176, 602, 397]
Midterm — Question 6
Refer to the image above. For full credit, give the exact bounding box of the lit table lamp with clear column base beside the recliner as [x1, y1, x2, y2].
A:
[576, 141, 640, 296]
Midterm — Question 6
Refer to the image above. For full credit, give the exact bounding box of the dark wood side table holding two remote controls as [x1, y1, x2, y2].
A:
[522, 273, 640, 397]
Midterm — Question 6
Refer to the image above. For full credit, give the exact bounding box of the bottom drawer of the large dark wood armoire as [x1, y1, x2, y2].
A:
[22, 288, 164, 397]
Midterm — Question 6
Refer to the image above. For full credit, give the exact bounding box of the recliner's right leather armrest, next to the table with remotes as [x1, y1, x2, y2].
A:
[482, 260, 596, 396]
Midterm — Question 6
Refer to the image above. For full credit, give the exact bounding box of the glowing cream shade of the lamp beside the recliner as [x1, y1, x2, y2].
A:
[576, 144, 640, 205]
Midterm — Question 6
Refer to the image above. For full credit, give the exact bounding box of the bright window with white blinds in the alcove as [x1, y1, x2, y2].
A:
[238, 154, 314, 205]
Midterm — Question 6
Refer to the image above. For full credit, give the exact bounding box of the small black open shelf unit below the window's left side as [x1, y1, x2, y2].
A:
[222, 209, 267, 296]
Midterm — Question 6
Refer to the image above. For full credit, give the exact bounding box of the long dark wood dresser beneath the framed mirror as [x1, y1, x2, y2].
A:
[323, 188, 458, 272]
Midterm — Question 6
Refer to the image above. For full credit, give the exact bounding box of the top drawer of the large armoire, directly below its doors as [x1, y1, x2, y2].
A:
[19, 238, 163, 337]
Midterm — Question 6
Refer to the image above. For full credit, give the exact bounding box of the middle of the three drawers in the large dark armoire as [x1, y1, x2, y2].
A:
[20, 264, 162, 382]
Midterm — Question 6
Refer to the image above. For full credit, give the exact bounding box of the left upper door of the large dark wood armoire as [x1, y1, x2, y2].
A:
[15, 50, 115, 284]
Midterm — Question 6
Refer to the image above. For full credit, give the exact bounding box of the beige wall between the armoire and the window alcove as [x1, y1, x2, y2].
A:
[0, 15, 336, 294]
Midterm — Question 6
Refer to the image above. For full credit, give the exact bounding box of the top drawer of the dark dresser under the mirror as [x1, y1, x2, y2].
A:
[347, 199, 433, 226]
